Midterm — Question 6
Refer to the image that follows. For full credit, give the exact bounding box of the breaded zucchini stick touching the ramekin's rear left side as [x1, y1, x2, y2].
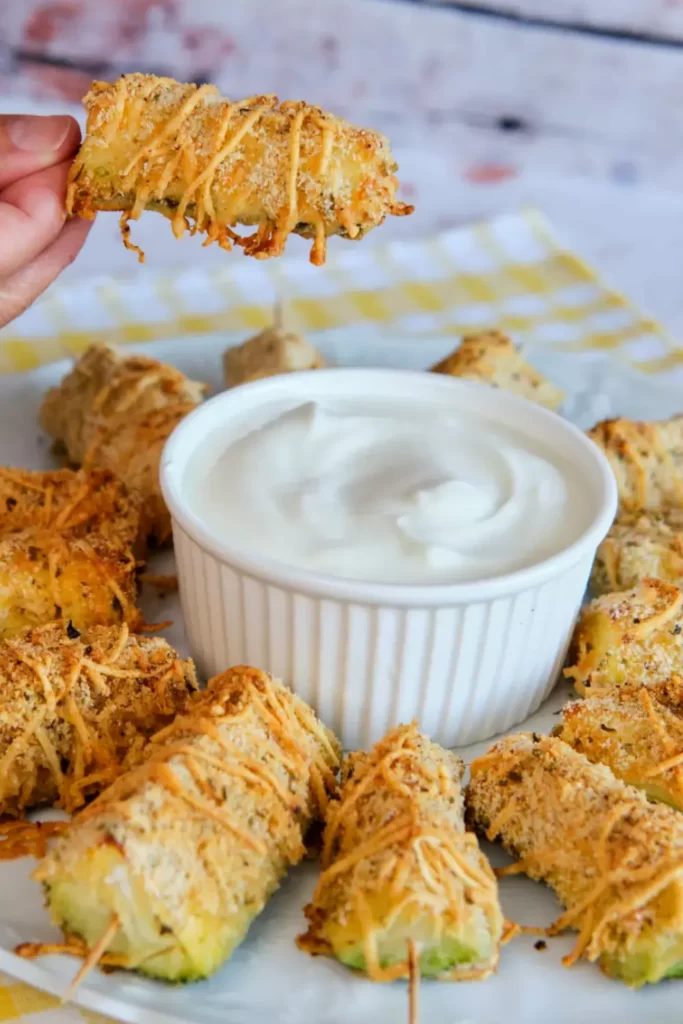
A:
[40, 345, 205, 544]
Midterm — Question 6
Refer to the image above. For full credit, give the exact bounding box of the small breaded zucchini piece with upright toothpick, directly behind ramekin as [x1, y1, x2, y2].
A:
[223, 327, 325, 387]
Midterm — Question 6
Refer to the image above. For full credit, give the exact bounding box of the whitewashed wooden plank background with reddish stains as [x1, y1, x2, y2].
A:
[0, 0, 683, 336]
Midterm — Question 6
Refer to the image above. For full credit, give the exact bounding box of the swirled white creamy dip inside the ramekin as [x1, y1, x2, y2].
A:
[190, 397, 589, 584]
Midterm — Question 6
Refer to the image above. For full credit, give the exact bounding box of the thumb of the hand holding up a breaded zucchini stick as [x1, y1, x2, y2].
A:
[0, 115, 81, 190]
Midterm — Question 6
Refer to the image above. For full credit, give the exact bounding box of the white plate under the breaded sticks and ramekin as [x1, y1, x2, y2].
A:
[0, 329, 683, 1024]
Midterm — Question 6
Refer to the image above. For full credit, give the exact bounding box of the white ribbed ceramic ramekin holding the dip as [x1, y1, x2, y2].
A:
[161, 370, 616, 749]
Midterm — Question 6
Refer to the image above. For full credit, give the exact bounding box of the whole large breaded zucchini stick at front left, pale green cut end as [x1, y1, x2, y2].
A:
[36, 667, 340, 981]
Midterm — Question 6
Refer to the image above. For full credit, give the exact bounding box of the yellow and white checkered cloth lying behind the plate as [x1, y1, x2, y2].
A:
[0, 211, 671, 373]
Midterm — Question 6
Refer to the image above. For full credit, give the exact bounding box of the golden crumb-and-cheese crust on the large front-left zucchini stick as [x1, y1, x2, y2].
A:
[36, 666, 341, 968]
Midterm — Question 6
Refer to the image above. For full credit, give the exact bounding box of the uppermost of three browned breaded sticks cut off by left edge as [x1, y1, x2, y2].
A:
[0, 467, 140, 548]
